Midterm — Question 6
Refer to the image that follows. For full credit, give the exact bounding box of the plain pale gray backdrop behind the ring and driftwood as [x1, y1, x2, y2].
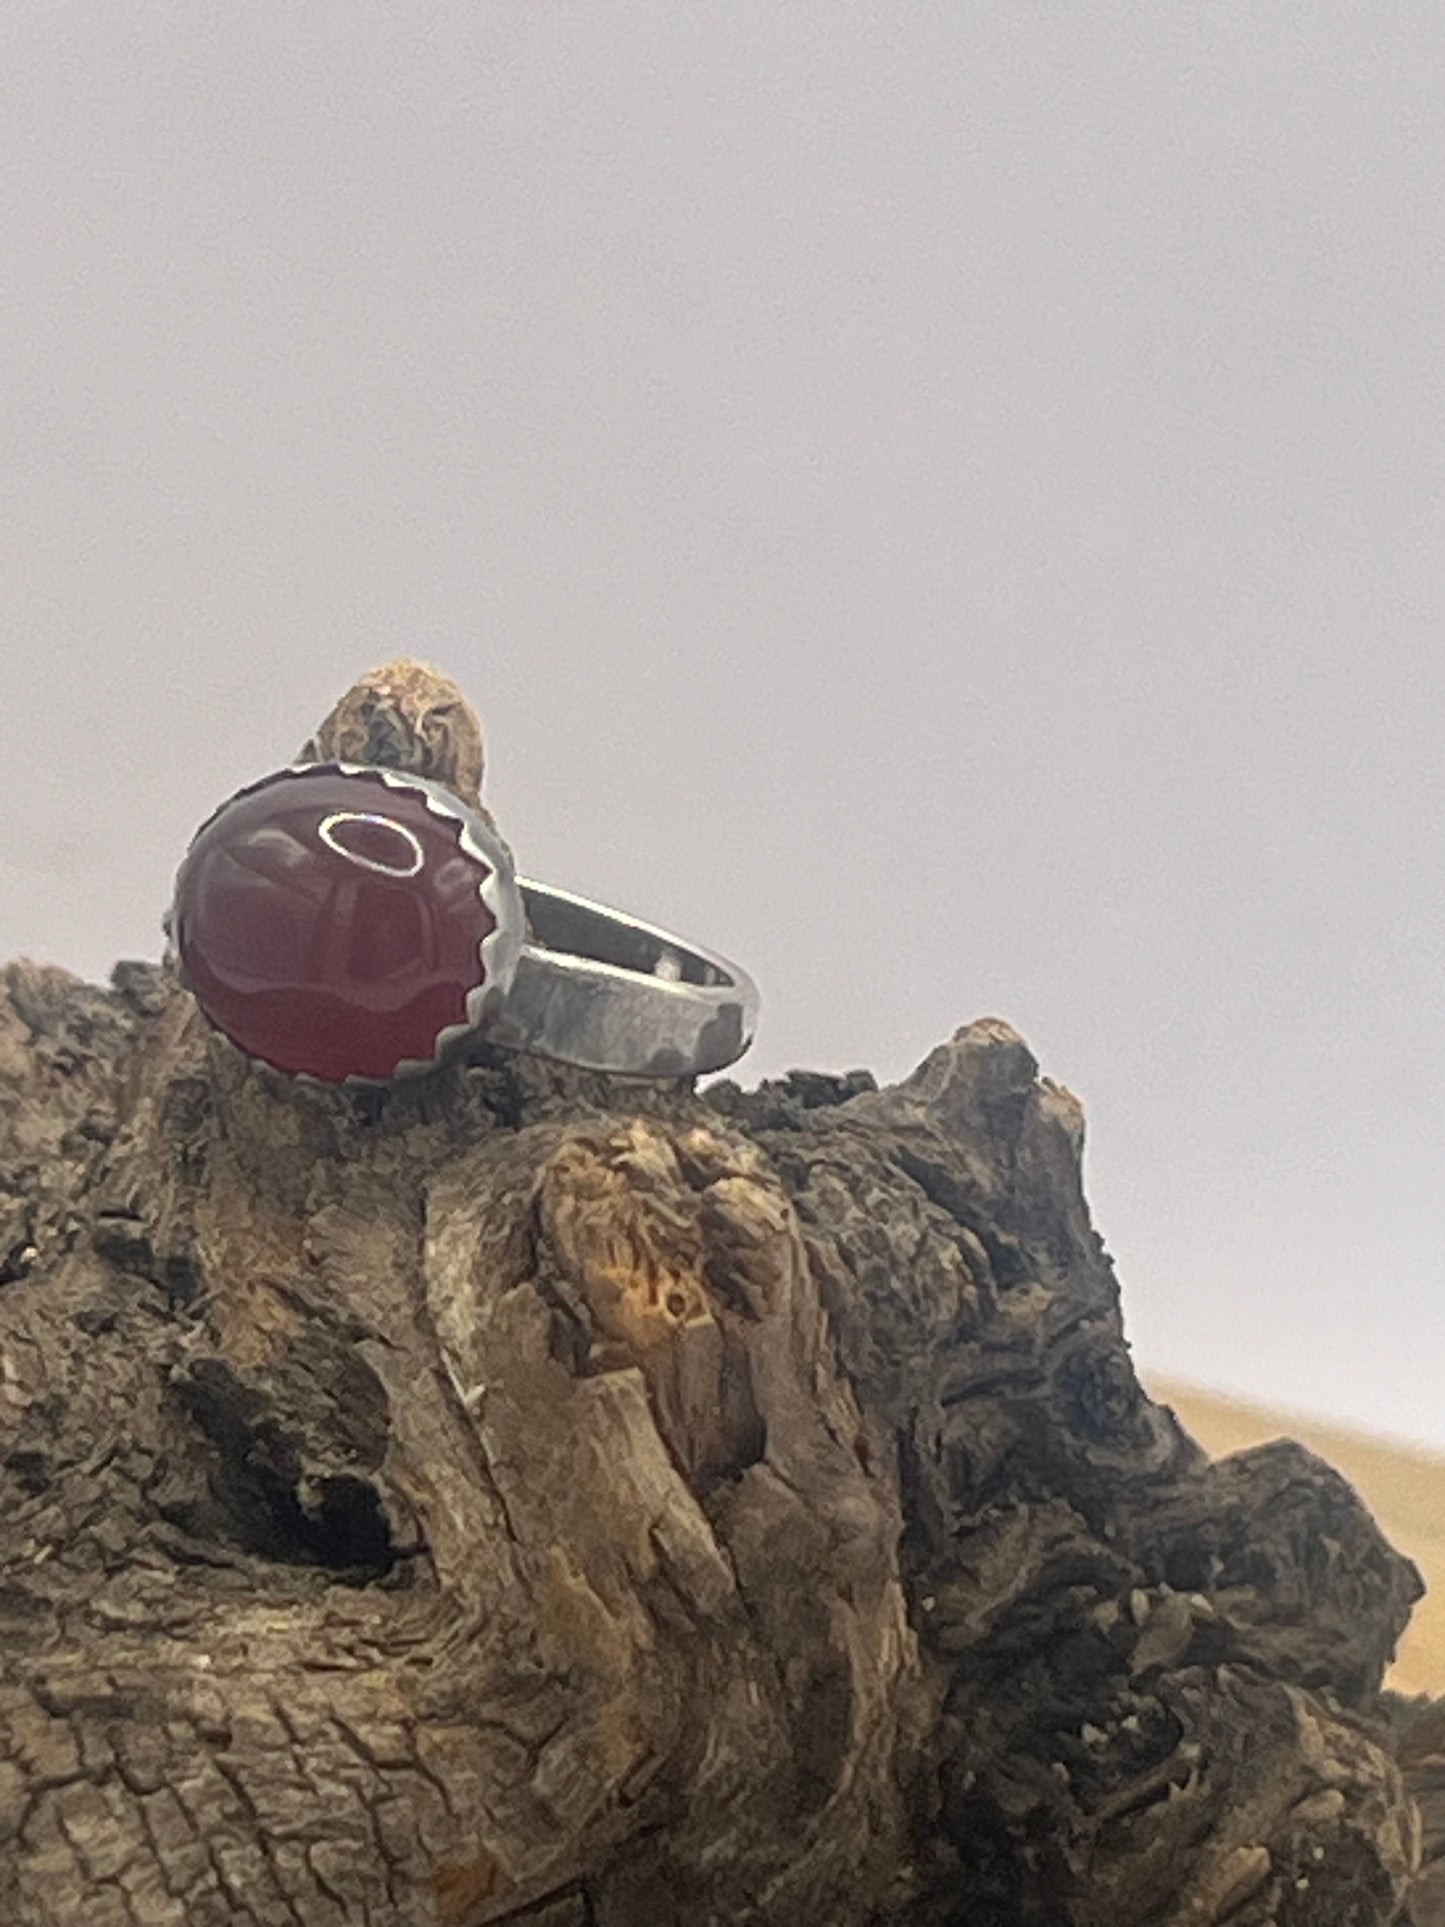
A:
[0, 0, 1445, 1443]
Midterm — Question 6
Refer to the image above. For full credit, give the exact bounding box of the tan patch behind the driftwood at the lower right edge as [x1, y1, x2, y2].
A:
[1148, 1378, 1445, 1696]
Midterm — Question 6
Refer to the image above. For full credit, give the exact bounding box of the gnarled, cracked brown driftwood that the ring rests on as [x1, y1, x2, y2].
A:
[0, 666, 1445, 1927]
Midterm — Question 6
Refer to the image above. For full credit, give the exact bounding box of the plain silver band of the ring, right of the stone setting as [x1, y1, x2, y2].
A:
[486, 877, 757, 1077]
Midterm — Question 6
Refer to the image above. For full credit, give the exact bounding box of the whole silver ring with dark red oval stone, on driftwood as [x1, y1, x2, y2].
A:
[166, 761, 757, 1085]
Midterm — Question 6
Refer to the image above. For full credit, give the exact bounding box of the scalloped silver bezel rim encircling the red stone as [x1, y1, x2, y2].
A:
[166, 761, 526, 1091]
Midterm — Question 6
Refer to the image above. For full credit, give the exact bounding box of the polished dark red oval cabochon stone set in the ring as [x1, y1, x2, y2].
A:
[171, 765, 495, 1083]
